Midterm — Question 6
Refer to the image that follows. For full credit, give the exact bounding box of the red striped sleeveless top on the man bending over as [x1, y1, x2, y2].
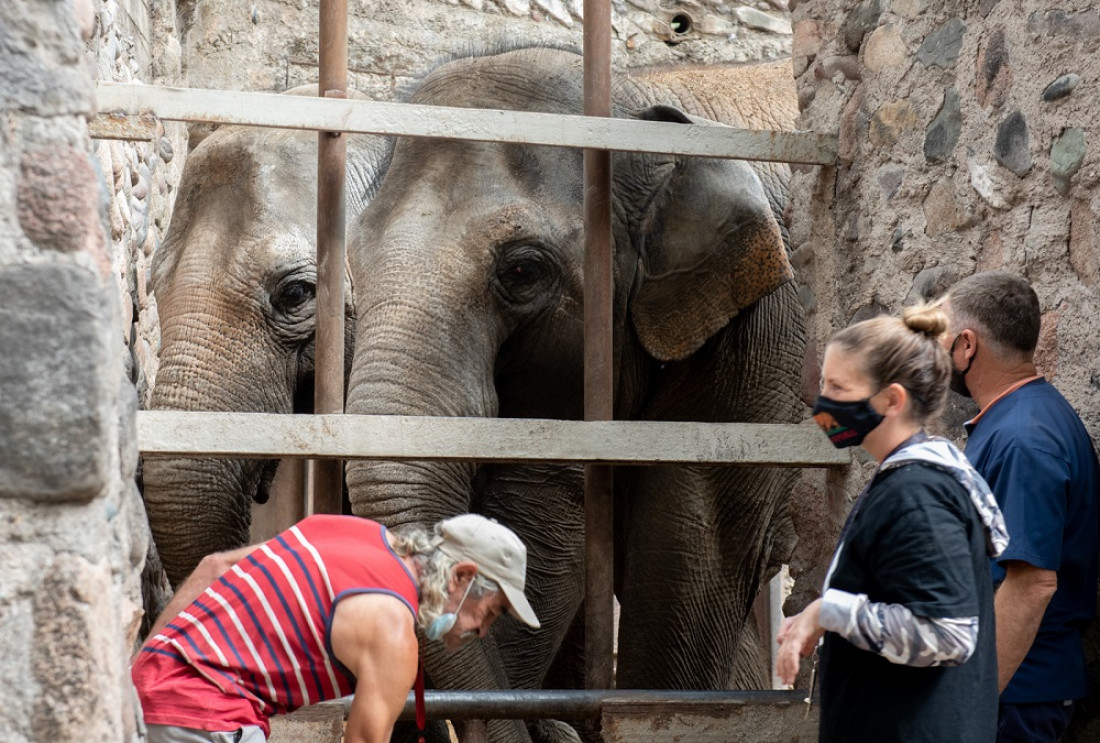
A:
[131, 515, 418, 733]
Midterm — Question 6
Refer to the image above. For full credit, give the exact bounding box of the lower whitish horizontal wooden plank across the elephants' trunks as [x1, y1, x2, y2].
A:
[138, 411, 849, 467]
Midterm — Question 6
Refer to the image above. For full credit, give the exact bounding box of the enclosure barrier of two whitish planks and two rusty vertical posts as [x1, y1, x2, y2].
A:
[90, 0, 848, 730]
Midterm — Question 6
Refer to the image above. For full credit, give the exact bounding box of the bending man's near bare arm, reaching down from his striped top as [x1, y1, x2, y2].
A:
[331, 593, 419, 743]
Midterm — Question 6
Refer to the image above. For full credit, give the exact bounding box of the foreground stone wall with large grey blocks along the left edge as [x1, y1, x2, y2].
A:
[0, 0, 145, 743]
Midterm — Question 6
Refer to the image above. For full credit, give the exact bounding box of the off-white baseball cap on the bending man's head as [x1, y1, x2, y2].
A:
[435, 513, 539, 629]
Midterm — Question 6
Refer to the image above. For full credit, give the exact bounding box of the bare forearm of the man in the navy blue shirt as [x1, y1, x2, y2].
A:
[993, 560, 1058, 691]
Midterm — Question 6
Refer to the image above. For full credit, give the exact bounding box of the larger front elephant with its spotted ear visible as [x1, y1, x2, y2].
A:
[347, 47, 805, 740]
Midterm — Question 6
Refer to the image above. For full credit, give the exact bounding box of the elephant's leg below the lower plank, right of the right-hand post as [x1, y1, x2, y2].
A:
[618, 467, 783, 689]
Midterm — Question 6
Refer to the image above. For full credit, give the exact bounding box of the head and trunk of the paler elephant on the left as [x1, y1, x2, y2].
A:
[144, 86, 389, 586]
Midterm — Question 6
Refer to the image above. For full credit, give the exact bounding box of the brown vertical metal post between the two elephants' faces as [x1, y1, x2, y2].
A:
[309, 0, 348, 513]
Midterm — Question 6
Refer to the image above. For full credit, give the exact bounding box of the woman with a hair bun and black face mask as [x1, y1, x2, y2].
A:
[777, 305, 1008, 743]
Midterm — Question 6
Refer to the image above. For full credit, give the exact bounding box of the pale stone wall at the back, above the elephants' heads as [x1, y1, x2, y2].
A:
[173, 0, 791, 100]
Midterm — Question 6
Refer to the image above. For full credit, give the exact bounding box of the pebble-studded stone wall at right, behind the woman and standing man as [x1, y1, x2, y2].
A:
[791, 0, 1100, 572]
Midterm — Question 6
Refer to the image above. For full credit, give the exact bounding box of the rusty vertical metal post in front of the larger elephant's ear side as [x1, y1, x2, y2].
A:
[584, 0, 615, 689]
